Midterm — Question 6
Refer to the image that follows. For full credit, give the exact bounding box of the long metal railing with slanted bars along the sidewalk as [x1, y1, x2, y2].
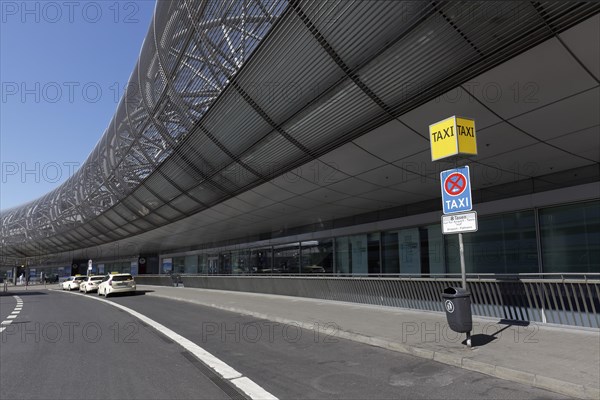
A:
[136, 273, 600, 328]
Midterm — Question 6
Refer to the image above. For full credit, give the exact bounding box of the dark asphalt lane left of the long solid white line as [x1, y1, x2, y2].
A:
[0, 290, 230, 400]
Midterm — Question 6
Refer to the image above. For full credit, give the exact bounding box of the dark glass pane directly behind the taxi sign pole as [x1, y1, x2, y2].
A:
[445, 211, 539, 274]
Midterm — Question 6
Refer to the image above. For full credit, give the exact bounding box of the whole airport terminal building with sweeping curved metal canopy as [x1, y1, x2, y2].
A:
[1, 0, 600, 327]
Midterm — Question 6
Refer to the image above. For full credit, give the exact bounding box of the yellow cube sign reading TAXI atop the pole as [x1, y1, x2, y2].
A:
[429, 116, 477, 161]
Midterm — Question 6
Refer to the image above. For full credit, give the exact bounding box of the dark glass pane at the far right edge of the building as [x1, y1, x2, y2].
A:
[539, 201, 600, 272]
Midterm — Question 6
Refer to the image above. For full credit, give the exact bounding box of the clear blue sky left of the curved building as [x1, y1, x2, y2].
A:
[0, 0, 155, 210]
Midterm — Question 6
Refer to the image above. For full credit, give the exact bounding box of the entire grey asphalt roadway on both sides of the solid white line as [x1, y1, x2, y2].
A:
[0, 291, 564, 399]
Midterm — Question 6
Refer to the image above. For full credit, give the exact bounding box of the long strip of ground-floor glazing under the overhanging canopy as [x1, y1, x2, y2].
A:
[157, 201, 600, 276]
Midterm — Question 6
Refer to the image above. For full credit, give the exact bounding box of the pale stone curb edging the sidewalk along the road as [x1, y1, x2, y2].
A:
[145, 292, 600, 400]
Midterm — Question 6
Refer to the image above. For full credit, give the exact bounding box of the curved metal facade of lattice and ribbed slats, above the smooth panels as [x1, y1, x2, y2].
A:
[2, 0, 600, 257]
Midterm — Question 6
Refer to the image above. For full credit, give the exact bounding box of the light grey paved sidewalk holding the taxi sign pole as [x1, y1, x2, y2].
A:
[138, 285, 600, 400]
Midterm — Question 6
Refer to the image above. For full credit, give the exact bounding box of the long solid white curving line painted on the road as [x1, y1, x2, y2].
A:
[50, 289, 278, 400]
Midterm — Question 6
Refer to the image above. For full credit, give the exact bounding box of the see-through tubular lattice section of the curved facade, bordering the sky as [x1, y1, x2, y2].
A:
[1, 0, 286, 256]
